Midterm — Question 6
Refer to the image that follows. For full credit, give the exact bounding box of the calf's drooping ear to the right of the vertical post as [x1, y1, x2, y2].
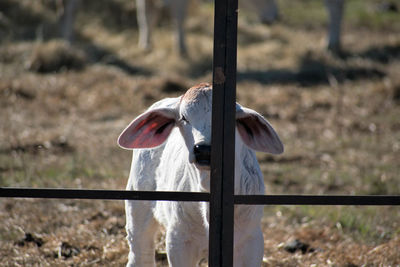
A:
[236, 107, 284, 154]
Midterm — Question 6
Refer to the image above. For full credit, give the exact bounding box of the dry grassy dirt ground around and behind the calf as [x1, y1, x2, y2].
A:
[0, 0, 400, 266]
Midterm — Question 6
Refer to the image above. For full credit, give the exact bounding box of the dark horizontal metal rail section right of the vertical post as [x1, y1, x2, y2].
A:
[234, 195, 400, 206]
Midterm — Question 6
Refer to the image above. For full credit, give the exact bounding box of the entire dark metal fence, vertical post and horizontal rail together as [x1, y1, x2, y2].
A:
[0, 0, 400, 267]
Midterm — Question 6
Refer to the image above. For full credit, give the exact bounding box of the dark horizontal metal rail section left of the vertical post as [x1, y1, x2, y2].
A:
[0, 187, 210, 202]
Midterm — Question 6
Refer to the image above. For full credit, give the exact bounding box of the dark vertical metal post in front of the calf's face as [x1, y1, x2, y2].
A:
[209, 0, 238, 267]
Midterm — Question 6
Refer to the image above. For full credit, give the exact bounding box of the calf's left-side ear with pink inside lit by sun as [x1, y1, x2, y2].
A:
[118, 108, 175, 149]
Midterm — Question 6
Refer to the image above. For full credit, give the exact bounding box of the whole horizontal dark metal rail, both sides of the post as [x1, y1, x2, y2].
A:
[0, 187, 400, 206]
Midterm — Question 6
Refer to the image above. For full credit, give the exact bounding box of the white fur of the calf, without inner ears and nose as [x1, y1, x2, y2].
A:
[120, 86, 283, 267]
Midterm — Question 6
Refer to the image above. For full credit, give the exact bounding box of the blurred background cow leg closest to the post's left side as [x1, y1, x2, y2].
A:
[168, 0, 189, 56]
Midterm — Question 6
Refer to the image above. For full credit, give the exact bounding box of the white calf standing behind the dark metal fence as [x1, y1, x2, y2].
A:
[118, 84, 283, 267]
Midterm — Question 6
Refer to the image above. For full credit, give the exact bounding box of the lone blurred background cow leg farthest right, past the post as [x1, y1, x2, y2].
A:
[325, 0, 344, 52]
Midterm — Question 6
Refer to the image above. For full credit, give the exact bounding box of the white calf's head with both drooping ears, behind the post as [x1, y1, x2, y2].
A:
[118, 83, 283, 169]
